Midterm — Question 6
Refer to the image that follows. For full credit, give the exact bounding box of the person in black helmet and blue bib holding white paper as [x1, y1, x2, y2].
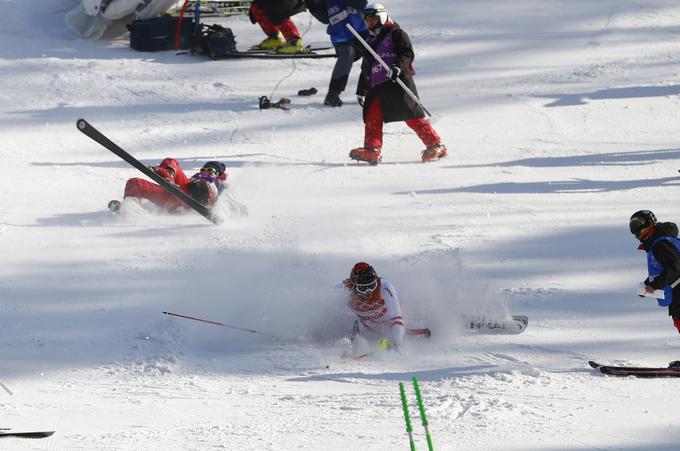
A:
[629, 210, 680, 333]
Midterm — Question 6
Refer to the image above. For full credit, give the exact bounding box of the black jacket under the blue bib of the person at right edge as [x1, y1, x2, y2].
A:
[642, 222, 680, 292]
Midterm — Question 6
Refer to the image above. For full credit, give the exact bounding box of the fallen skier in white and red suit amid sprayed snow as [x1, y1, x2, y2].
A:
[343, 262, 406, 349]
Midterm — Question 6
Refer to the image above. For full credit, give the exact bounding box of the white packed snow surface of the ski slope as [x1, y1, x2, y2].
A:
[0, 0, 680, 451]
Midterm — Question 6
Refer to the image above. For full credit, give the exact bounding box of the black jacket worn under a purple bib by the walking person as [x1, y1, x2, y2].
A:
[357, 22, 425, 122]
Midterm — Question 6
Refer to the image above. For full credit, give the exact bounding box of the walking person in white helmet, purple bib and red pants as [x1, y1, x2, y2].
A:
[349, 3, 446, 165]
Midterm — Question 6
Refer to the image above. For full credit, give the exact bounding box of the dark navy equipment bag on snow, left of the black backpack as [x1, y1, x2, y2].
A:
[128, 16, 194, 52]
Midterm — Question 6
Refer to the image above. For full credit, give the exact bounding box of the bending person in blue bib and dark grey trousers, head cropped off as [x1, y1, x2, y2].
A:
[307, 0, 367, 107]
